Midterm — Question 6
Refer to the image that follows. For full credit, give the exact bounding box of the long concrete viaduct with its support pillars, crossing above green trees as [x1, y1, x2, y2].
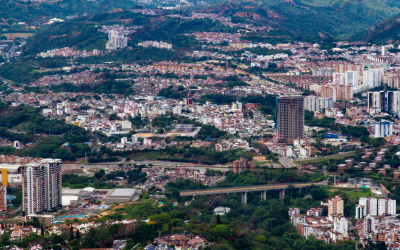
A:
[180, 181, 327, 204]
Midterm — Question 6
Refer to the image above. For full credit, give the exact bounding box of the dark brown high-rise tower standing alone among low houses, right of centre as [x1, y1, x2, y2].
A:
[275, 96, 304, 143]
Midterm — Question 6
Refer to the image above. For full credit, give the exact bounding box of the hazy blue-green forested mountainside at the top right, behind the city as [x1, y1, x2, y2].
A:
[190, 0, 400, 39]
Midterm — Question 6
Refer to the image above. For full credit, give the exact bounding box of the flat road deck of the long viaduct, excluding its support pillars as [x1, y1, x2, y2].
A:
[180, 182, 327, 196]
